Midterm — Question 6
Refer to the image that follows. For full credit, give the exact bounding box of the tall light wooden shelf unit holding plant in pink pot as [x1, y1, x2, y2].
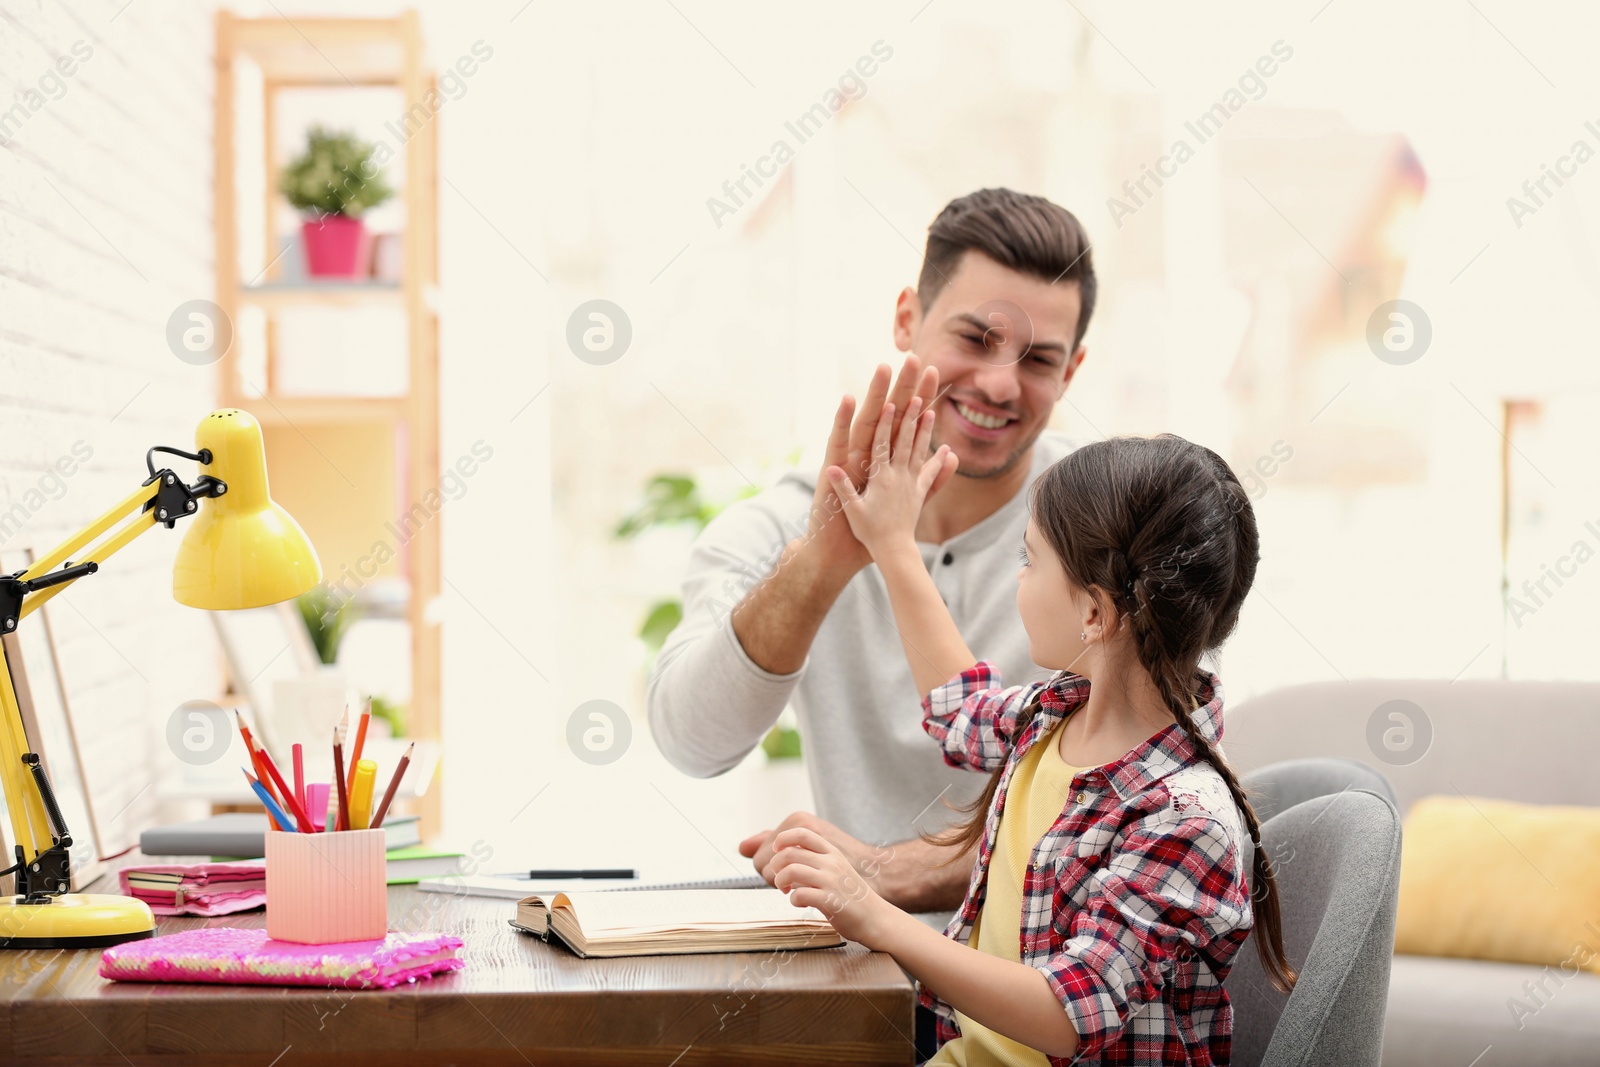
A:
[214, 11, 440, 837]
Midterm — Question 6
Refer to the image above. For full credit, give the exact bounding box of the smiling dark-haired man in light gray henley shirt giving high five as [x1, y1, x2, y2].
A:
[648, 189, 1096, 912]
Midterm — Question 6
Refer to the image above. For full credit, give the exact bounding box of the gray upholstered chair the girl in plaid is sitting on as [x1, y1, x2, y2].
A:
[1226, 789, 1400, 1067]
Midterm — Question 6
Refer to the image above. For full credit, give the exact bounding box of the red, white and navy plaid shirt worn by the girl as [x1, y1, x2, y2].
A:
[918, 662, 1254, 1067]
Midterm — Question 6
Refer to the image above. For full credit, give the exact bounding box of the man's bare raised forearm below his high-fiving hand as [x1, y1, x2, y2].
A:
[733, 537, 850, 675]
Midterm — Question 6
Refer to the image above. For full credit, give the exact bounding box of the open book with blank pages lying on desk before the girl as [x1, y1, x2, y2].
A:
[510, 888, 845, 958]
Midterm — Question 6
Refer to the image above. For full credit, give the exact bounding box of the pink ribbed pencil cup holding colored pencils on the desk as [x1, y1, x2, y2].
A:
[267, 830, 389, 945]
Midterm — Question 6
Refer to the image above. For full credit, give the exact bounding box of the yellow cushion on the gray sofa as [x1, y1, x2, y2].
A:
[1395, 795, 1600, 974]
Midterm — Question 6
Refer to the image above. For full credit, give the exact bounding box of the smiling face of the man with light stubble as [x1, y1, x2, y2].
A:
[894, 251, 1083, 478]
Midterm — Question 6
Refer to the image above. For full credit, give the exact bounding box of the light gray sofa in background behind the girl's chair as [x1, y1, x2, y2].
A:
[1224, 680, 1600, 1067]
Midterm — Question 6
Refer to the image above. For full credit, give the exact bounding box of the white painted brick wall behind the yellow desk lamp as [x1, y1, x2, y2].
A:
[0, 0, 219, 853]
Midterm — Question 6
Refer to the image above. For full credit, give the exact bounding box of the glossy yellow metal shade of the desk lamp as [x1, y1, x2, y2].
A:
[173, 408, 322, 611]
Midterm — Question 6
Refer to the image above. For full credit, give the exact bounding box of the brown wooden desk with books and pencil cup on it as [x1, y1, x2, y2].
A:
[0, 880, 915, 1067]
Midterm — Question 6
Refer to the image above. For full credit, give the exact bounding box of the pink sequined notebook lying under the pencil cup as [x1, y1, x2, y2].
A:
[99, 926, 466, 989]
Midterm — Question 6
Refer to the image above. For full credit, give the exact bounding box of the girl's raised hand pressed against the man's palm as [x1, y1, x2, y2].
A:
[827, 397, 957, 560]
